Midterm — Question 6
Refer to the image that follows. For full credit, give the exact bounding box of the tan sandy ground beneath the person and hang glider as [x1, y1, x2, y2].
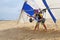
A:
[0, 20, 60, 40]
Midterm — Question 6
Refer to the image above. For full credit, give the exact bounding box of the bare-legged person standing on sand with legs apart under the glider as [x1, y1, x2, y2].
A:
[34, 9, 47, 31]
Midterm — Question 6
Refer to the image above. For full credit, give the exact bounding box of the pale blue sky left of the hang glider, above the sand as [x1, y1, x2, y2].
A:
[0, 0, 24, 20]
